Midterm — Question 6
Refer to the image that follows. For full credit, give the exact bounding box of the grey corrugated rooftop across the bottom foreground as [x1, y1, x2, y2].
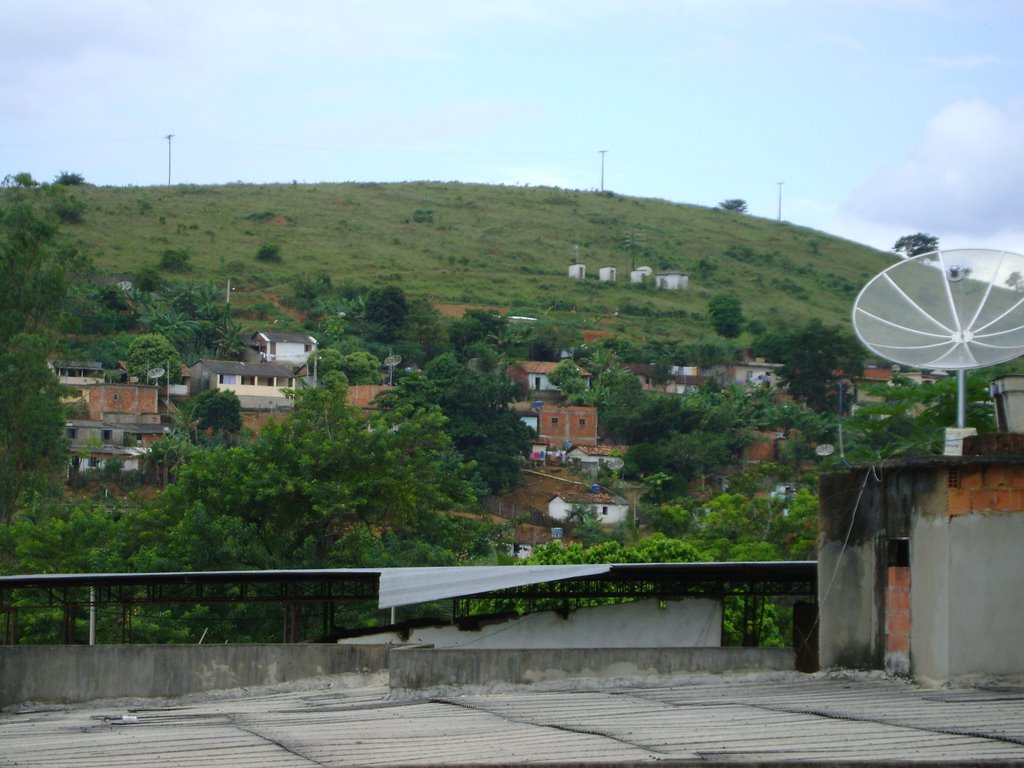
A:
[0, 673, 1024, 768]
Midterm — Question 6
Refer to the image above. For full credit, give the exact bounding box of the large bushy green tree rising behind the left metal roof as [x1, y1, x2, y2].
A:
[153, 388, 483, 569]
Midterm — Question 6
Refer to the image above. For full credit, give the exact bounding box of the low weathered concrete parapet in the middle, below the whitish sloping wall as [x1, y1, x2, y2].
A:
[389, 647, 796, 690]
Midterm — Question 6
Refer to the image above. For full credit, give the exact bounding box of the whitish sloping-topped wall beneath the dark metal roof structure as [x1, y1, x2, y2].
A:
[341, 600, 722, 649]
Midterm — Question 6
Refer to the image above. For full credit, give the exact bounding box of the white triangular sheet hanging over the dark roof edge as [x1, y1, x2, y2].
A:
[379, 564, 611, 608]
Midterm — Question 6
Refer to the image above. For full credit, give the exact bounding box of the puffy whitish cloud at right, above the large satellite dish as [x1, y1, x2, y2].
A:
[840, 100, 1024, 245]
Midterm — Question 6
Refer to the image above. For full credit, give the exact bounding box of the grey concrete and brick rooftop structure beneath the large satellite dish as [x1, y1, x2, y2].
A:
[818, 453, 1024, 684]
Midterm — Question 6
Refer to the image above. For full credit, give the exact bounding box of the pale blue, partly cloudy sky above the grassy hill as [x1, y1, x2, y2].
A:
[0, 0, 1024, 253]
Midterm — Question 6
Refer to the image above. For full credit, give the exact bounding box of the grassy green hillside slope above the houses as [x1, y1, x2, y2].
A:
[69, 182, 894, 341]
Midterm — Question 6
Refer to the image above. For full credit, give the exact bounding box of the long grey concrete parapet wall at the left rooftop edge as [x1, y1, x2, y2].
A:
[0, 644, 387, 707]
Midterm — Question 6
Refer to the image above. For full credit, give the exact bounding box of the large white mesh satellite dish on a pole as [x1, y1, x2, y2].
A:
[853, 248, 1024, 427]
